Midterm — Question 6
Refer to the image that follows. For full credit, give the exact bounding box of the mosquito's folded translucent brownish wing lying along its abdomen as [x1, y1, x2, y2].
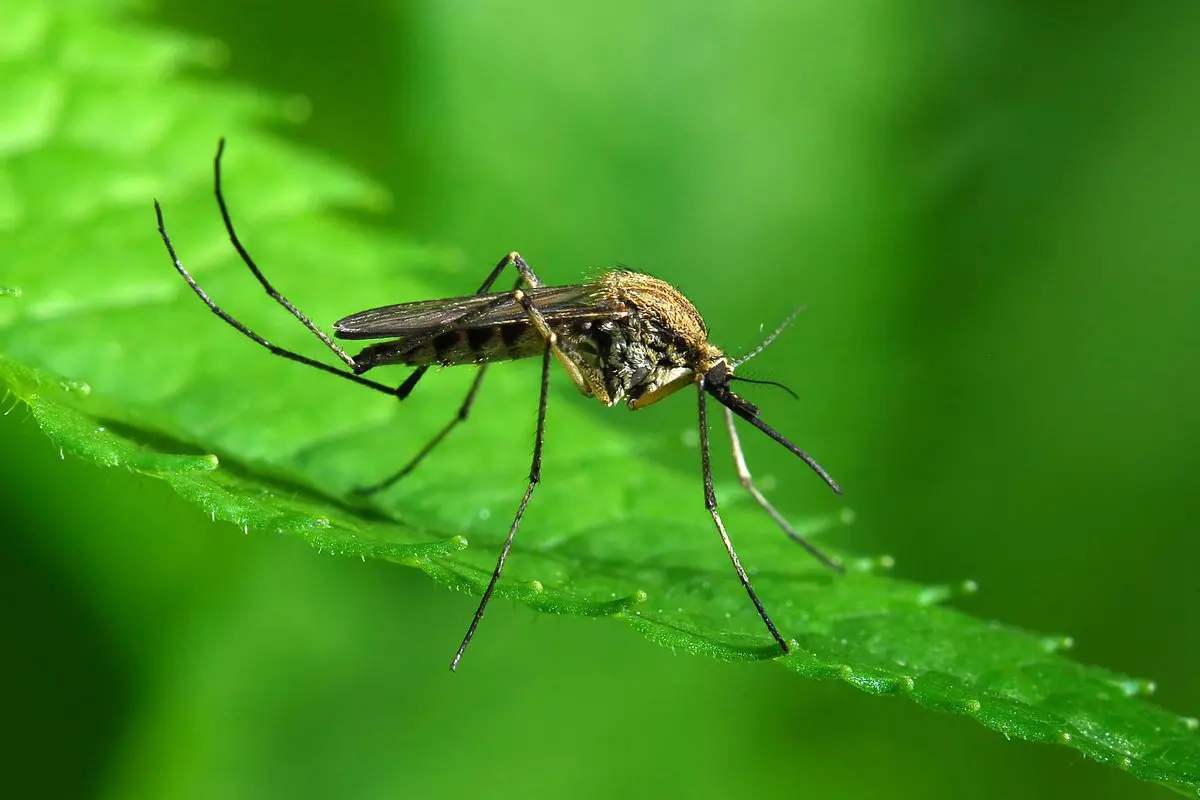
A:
[334, 283, 625, 339]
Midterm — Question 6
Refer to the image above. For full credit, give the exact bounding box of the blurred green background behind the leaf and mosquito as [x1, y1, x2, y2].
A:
[0, 0, 1200, 798]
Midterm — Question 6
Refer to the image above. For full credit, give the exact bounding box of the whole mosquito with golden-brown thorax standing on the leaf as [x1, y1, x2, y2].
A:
[154, 139, 842, 670]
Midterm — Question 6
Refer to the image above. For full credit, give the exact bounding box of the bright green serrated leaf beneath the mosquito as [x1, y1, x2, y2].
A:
[0, 4, 1200, 792]
